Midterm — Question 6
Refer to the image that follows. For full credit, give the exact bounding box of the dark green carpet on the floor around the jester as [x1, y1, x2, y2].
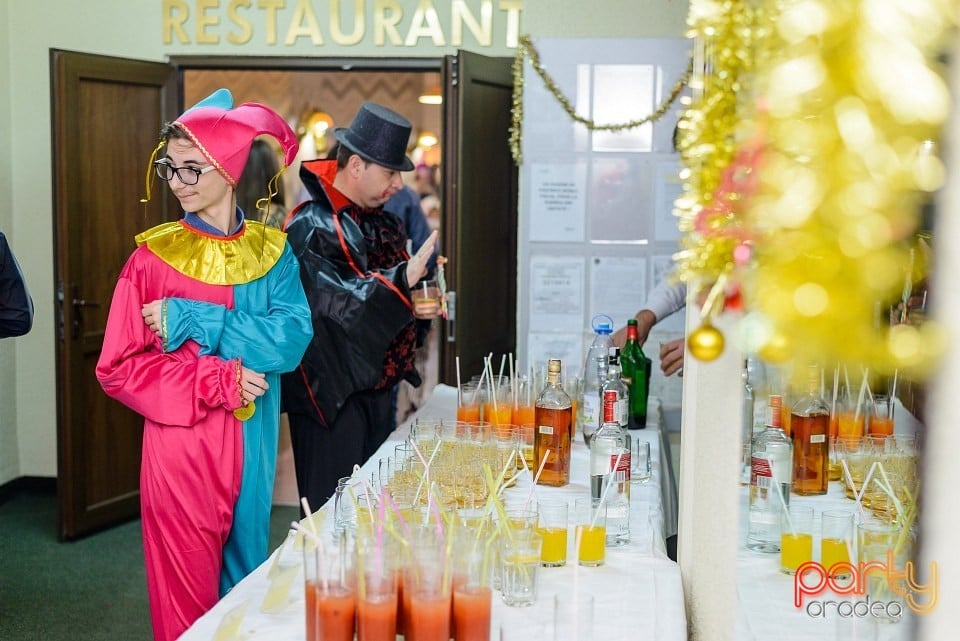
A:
[0, 482, 299, 641]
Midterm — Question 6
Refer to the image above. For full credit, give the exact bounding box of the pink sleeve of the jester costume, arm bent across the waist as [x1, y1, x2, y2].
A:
[97, 269, 241, 427]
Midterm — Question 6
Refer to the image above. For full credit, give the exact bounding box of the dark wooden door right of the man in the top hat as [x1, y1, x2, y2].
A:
[440, 51, 518, 385]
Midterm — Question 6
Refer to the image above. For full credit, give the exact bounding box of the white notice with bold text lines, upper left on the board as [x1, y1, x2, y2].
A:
[530, 162, 587, 242]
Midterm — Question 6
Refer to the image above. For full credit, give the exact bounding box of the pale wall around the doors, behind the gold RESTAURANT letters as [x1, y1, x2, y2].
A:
[0, 0, 687, 485]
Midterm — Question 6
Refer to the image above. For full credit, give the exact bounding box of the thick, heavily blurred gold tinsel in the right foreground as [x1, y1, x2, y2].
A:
[743, 0, 950, 377]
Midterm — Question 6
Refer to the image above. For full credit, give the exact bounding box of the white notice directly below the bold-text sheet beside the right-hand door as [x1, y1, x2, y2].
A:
[530, 256, 584, 332]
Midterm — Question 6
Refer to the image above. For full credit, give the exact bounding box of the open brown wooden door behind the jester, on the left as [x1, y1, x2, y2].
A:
[51, 51, 177, 539]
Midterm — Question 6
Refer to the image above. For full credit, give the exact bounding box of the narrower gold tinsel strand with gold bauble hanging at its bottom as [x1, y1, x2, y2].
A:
[674, 0, 769, 360]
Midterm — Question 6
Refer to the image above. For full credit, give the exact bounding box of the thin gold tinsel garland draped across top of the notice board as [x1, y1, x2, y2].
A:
[510, 35, 693, 165]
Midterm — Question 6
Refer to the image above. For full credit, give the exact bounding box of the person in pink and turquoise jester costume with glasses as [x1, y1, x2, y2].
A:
[96, 89, 313, 641]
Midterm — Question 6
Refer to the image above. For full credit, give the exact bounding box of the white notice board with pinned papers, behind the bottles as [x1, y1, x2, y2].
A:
[517, 38, 691, 407]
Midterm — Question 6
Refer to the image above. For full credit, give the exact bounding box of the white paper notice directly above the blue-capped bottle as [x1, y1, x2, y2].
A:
[590, 256, 647, 328]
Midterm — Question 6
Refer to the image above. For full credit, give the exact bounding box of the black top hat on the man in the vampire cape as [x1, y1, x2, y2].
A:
[333, 102, 413, 171]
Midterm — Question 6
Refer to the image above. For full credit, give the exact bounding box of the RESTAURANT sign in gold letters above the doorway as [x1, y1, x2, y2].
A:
[161, 0, 523, 48]
